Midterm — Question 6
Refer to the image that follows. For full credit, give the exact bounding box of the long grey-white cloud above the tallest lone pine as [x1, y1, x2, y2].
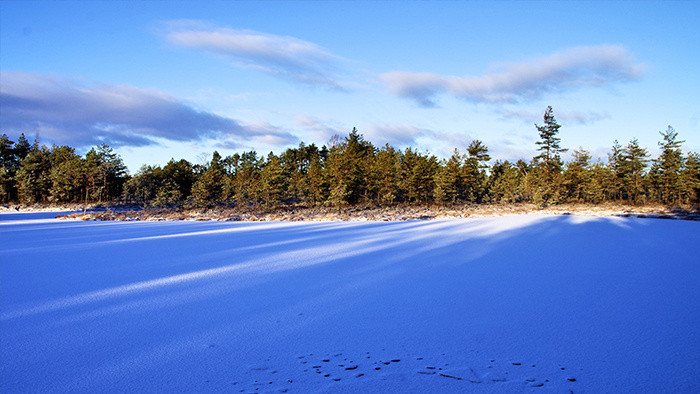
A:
[380, 45, 643, 107]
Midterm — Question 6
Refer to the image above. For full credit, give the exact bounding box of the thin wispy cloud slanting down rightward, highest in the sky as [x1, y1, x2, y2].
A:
[164, 21, 346, 90]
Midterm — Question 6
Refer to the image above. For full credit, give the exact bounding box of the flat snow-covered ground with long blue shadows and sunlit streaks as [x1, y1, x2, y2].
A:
[0, 213, 700, 393]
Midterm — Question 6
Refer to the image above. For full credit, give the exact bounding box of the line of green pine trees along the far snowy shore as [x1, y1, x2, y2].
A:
[0, 107, 700, 207]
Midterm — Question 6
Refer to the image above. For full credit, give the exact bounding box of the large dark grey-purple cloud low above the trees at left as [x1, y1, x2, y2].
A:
[0, 71, 296, 147]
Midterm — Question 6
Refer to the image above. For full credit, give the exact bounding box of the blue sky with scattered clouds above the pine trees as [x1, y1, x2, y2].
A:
[0, 0, 700, 174]
